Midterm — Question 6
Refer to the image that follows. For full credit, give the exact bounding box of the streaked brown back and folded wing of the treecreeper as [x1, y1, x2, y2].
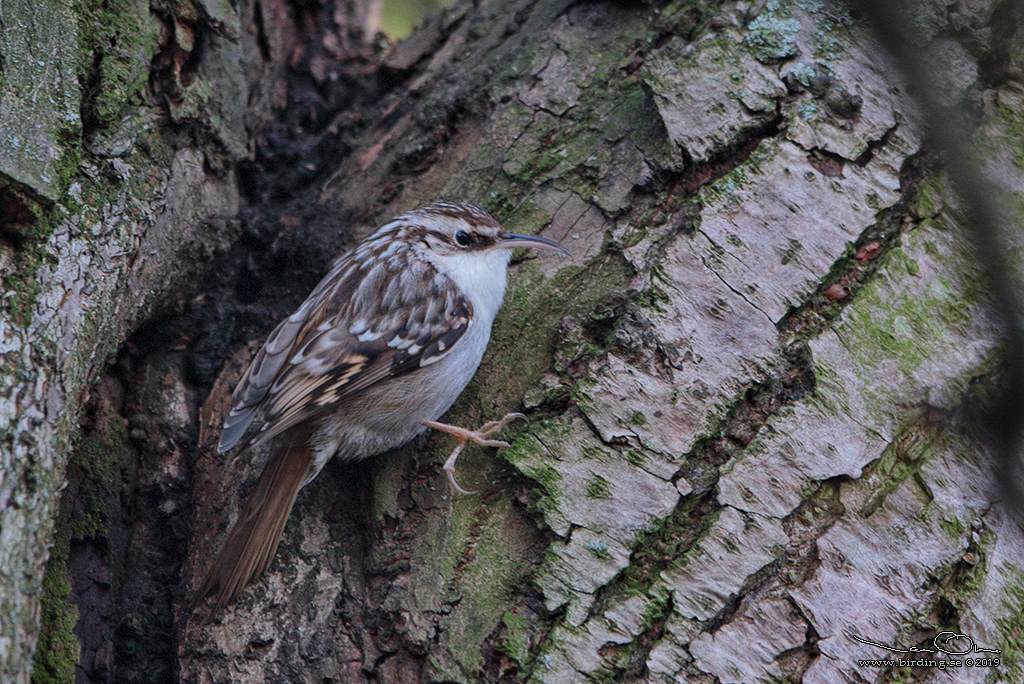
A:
[219, 235, 473, 452]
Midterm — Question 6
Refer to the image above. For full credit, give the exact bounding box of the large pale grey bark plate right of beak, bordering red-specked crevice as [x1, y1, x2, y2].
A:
[695, 139, 912, 324]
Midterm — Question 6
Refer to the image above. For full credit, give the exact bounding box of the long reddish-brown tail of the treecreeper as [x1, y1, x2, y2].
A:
[196, 430, 312, 616]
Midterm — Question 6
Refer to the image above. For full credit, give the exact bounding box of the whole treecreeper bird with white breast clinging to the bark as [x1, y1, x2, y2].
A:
[198, 203, 565, 614]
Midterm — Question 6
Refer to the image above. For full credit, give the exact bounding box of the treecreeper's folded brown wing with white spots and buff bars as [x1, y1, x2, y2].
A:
[225, 253, 473, 445]
